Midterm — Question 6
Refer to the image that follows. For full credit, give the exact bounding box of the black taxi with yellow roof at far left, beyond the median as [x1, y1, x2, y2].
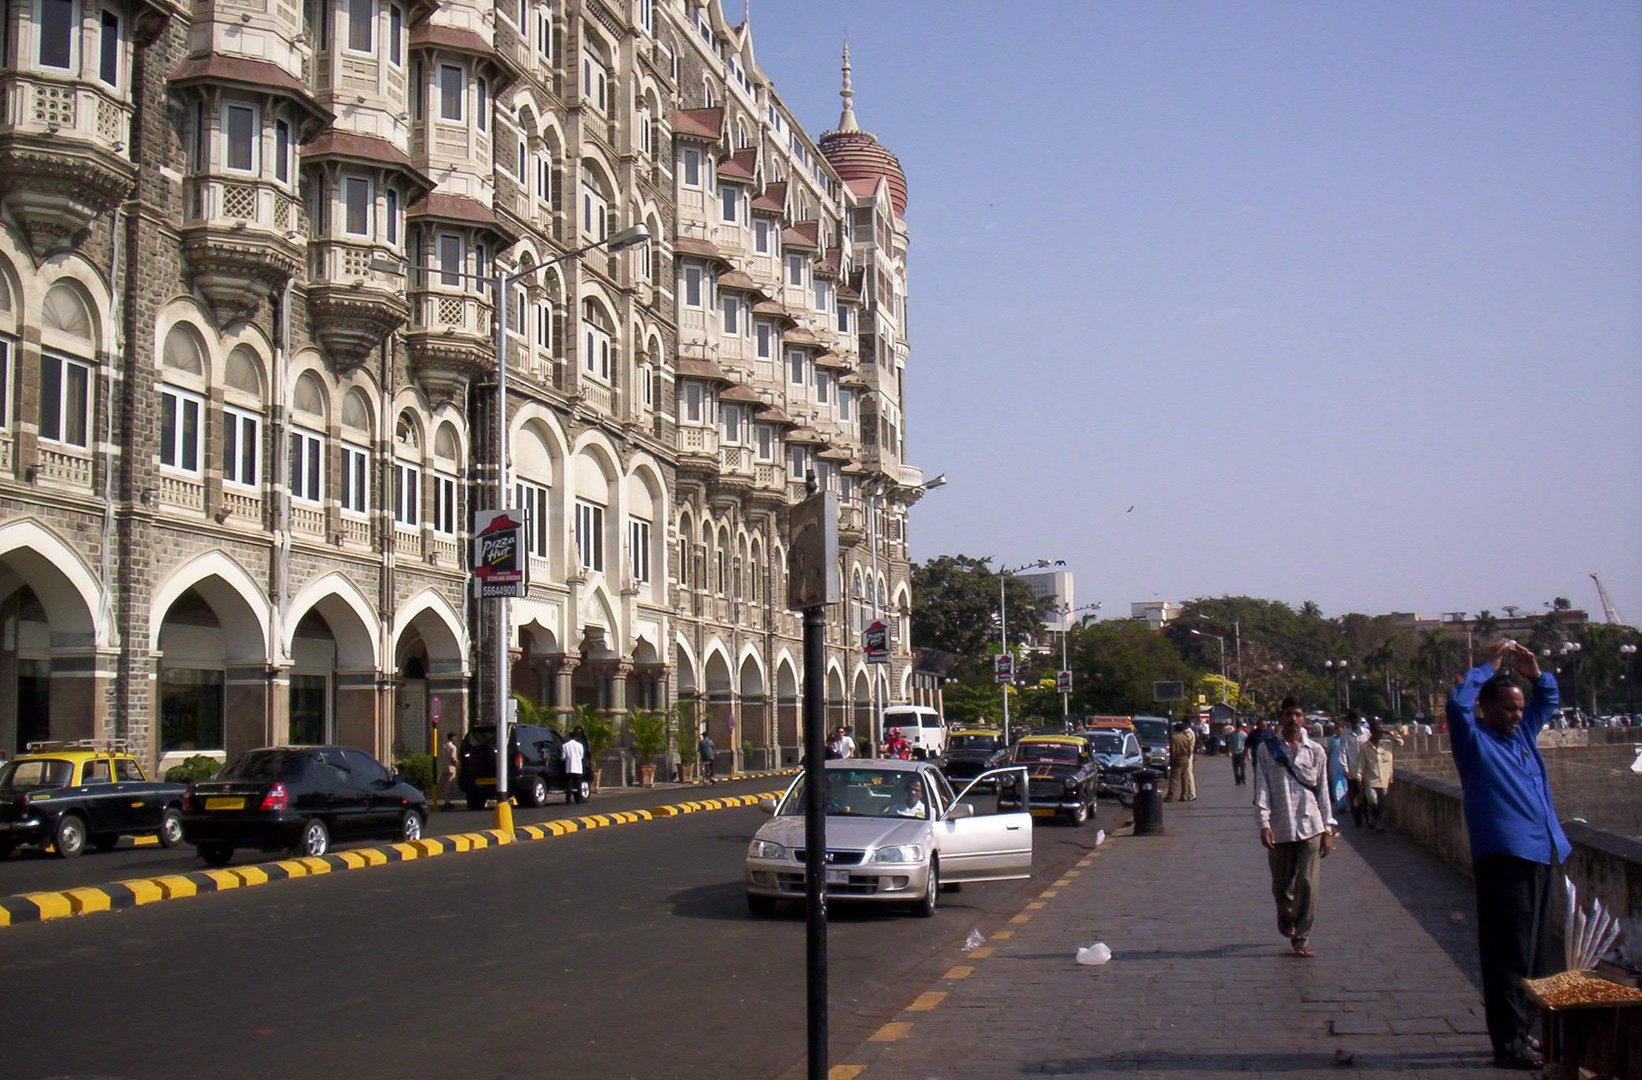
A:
[0, 740, 187, 858]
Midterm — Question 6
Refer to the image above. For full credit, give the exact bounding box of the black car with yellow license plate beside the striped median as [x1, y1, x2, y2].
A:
[182, 747, 429, 867]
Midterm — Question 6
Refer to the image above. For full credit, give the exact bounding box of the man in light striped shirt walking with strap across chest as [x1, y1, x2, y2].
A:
[1254, 698, 1335, 957]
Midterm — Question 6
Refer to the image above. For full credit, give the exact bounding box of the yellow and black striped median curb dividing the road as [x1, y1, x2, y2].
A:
[0, 773, 794, 926]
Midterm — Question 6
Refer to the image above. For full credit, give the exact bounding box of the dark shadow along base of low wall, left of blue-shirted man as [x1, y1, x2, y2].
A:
[1340, 824, 1483, 990]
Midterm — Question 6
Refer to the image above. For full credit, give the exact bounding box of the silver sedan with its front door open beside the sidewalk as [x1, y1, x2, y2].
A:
[747, 758, 1033, 916]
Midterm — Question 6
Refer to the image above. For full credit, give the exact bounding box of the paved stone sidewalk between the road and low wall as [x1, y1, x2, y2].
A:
[831, 757, 1524, 1080]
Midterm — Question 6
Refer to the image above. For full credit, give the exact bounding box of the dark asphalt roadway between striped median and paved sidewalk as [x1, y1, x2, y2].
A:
[0, 781, 1115, 1080]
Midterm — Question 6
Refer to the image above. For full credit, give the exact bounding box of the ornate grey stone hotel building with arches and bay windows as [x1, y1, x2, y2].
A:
[0, 0, 923, 767]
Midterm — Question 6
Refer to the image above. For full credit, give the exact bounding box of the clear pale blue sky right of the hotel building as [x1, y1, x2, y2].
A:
[748, 0, 1642, 622]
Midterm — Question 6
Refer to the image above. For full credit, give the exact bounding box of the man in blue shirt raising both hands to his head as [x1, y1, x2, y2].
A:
[1448, 642, 1570, 1069]
